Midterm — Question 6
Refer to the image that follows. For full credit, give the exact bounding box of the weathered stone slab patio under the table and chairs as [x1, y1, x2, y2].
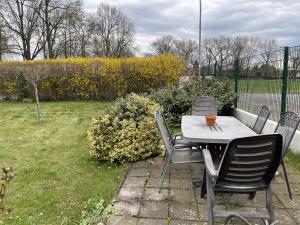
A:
[108, 157, 300, 225]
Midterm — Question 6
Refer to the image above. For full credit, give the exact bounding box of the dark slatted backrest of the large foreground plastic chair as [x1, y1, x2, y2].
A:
[216, 134, 282, 191]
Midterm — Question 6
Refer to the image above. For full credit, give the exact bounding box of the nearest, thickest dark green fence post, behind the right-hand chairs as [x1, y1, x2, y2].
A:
[280, 47, 289, 116]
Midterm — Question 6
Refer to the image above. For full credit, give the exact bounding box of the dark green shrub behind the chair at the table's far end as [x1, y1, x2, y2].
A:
[149, 79, 236, 123]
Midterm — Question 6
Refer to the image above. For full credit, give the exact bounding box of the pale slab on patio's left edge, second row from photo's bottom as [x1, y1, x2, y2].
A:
[113, 202, 140, 216]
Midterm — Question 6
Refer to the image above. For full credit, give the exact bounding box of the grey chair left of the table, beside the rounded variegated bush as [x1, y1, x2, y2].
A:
[154, 110, 203, 192]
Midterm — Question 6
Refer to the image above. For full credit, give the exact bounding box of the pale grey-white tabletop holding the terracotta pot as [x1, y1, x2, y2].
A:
[181, 116, 257, 144]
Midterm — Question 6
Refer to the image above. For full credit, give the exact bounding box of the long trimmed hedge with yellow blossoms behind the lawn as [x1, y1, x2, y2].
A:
[0, 55, 186, 100]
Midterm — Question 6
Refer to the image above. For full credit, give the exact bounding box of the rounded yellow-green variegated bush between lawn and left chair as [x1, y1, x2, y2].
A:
[88, 94, 161, 163]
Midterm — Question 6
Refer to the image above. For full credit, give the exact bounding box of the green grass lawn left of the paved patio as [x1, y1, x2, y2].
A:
[0, 102, 126, 225]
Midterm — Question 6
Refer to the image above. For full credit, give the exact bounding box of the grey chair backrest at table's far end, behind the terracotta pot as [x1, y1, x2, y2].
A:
[192, 96, 217, 116]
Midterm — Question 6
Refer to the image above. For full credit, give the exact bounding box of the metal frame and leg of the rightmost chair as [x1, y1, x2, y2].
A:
[274, 111, 300, 199]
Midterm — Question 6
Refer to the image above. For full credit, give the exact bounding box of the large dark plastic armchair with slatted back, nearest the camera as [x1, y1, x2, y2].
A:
[203, 134, 282, 225]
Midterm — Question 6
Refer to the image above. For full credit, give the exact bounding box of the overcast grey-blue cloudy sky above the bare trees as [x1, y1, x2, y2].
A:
[84, 0, 300, 54]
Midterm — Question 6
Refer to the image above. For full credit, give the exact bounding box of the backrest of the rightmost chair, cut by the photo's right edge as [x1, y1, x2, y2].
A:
[274, 112, 300, 157]
